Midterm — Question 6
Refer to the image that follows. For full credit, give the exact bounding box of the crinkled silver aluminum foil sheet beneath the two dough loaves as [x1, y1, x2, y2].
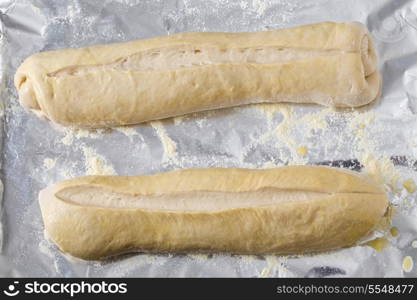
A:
[0, 0, 417, 277]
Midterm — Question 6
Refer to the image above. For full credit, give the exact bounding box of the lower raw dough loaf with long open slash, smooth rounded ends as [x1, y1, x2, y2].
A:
[39, 166, 389, 260]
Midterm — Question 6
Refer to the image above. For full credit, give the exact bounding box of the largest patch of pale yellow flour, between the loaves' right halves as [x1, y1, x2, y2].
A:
[255, 103, 404, 198]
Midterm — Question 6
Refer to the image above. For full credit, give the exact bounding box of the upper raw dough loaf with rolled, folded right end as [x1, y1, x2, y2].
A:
[15, 22, 381, 127]
